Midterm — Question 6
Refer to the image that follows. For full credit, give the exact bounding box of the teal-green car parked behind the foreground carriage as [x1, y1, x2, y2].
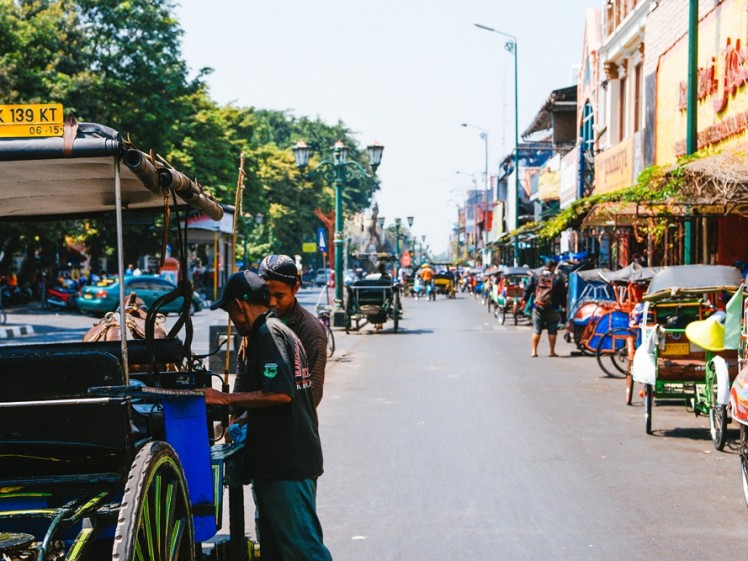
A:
[76, 275, 203, 316]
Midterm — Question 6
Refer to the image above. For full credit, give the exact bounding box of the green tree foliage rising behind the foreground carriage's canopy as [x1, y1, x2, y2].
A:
[0, 0, 378, 271]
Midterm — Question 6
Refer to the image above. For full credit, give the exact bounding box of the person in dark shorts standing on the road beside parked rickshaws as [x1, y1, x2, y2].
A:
[523, 259, 566, 357]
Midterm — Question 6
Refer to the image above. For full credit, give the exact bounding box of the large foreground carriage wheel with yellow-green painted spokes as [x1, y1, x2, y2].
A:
[112, 441, 195, 561]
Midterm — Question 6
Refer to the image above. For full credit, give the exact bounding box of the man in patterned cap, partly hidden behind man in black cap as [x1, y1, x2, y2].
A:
[258, 255, 327, 407]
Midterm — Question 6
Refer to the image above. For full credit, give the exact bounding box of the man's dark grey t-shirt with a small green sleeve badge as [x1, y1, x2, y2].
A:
[234, 312, 322, 480]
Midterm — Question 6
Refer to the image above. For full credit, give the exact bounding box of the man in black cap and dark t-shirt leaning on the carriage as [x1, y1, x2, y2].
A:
[203, 271, 332, 561]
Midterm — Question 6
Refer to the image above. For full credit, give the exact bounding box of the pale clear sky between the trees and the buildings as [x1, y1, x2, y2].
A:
[176, 0, 601, 252]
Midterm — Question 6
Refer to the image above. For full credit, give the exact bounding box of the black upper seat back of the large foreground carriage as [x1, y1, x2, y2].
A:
[0, 350, 124, 402]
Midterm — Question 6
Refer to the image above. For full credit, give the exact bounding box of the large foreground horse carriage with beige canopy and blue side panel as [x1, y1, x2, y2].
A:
[0, 116, 252, 561]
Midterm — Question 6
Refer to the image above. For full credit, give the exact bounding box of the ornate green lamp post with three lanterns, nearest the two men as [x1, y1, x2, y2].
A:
[293, 140, 384, 327]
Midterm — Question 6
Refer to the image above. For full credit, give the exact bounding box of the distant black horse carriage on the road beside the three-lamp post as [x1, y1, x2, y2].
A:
[345, 253, 403, 333]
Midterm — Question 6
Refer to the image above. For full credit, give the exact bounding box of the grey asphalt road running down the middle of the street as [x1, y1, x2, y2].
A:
[318, 294, 748, 561]
